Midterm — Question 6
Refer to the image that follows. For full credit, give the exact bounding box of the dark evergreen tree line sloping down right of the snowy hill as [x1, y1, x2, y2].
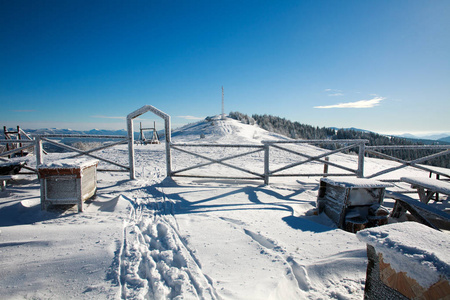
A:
[229, 112, 450, 168]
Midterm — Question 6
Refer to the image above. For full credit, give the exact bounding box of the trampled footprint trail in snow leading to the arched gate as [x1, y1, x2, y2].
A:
[119, 178, 218, 299]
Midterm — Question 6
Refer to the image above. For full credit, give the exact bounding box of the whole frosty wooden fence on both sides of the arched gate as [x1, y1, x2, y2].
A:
[0, 134, 450, 184]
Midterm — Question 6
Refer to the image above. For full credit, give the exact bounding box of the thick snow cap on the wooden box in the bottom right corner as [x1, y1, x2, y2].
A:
[357, 222, 450, 288]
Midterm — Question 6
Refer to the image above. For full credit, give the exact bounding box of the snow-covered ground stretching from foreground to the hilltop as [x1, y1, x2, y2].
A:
[0, 119, 448, 299]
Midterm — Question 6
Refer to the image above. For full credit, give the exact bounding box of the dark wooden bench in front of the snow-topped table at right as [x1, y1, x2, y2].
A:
[385, 191, 450, 230]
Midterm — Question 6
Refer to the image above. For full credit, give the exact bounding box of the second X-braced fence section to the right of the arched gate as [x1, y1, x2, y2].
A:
[263, 140, 368, 184]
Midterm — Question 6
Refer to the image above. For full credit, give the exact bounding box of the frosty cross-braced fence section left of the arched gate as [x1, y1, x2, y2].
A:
[35, 134, 130, 172]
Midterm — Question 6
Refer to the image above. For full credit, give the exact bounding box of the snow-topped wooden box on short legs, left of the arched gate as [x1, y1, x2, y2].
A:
[38, 159, 98, 212]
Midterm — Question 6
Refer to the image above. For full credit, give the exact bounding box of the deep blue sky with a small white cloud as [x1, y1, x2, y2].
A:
[0, 0, 450, 133]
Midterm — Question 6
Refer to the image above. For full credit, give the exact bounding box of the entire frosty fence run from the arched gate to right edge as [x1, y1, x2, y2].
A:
[170, 139, 450, 184]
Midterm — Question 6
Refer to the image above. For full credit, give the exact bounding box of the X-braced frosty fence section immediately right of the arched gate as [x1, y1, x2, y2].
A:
[170, 143, 264, 179]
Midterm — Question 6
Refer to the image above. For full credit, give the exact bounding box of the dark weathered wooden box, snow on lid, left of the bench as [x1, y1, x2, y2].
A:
[317, 178, 392, 232]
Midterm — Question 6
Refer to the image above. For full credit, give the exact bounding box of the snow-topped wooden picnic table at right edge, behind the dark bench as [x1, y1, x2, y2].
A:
[400, 177, 450, 203]
